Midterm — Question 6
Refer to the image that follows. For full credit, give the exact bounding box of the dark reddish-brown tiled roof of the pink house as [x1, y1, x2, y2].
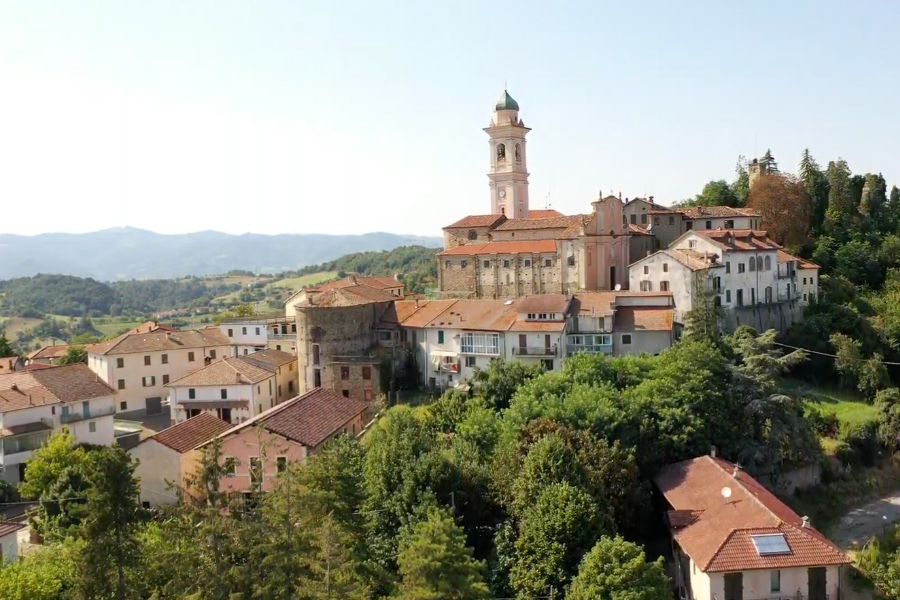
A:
[209, 388, 368, 448]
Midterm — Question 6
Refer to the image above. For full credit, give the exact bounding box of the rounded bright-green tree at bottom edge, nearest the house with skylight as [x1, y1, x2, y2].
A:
[566, 536, 672, 600]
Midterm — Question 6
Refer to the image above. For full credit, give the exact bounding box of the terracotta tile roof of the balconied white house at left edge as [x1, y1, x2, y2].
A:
[0, 364, 116, 413]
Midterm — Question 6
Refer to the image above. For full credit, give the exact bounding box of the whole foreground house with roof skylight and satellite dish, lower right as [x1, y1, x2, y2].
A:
[656, 456, 851, 600]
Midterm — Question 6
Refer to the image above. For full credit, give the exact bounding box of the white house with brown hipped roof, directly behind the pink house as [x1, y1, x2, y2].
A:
[166, 357, 278, 425]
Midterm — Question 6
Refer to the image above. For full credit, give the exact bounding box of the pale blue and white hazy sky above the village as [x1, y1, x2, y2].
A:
[0, 0, 900, 235]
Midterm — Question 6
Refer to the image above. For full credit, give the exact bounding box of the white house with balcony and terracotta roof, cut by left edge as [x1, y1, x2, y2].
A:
[0, 364, 116, 484]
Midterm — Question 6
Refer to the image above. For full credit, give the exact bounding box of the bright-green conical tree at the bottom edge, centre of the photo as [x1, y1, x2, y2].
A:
[394, 508, 489, 600]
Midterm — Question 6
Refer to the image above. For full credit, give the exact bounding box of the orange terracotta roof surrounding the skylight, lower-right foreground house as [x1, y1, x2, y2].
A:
[656, 456, 850, 572]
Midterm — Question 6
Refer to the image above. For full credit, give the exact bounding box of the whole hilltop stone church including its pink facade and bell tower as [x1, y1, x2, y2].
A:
[437, 90, 653, 298]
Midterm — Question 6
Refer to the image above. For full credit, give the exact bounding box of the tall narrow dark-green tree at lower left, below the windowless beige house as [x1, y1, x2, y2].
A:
[76, 446, 142, 600]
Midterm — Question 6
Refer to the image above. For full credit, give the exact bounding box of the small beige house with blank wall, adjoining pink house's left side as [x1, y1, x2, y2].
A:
[128, 412, 231, 508]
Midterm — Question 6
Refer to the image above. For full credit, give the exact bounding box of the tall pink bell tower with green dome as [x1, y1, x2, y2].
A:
[484, 90, 531, 219]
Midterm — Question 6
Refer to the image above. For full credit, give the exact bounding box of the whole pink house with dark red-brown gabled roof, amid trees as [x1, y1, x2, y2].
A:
[201, 388, 369, 492]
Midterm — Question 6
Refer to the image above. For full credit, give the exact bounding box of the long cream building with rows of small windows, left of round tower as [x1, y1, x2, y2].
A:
[87, 327, 232, 417]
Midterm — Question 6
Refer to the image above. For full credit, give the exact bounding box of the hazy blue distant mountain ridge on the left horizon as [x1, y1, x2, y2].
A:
[0, 227, 443, 281]
